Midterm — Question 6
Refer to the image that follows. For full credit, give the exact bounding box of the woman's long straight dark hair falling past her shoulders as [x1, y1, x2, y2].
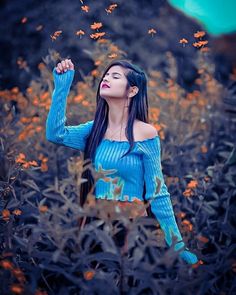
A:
[80, 60, 152, 213]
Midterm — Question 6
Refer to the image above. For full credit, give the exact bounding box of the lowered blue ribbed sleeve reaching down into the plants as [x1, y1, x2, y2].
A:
[143, 136, 198, 264]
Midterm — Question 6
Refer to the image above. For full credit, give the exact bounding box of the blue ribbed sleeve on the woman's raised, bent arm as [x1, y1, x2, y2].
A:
[46, 68, 93, 151]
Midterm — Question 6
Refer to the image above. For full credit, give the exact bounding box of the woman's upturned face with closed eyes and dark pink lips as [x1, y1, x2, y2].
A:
[100, 66, 128, 99]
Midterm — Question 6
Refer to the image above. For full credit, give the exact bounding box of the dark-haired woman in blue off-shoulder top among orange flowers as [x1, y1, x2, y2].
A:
[46, 59, 198, 264]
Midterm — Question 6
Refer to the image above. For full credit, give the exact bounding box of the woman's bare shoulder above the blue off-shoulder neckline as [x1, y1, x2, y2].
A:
[134, 120, 158, 141]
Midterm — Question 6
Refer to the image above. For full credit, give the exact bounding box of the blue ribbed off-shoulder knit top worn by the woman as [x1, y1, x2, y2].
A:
[46, 68, 198, 264]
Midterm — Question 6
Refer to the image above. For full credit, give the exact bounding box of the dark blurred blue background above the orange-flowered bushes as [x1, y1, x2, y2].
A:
[0, 0, 236, 91]
